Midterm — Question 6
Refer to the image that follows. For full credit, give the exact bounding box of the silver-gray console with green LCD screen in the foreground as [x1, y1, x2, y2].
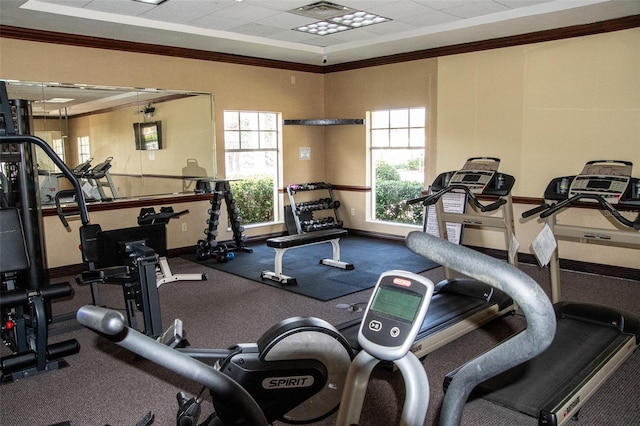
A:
[358, 270, 434, 361]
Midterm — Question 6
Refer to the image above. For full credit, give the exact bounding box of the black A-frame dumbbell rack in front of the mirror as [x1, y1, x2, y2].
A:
[196, 179, 253, 259]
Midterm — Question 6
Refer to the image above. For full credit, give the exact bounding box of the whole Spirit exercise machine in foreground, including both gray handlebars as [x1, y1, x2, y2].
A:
[77, 232, 555, 426]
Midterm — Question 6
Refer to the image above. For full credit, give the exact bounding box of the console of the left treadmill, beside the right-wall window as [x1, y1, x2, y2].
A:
[432, 157, 515, 197]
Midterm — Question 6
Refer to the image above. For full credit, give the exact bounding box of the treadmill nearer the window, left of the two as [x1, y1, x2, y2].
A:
[337, 157, 517, 358]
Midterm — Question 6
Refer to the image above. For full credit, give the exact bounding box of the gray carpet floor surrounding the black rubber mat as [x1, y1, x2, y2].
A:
[0, 258, 640, 426]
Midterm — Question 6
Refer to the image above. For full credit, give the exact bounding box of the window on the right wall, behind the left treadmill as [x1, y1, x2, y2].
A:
[367, 108, 426, 225]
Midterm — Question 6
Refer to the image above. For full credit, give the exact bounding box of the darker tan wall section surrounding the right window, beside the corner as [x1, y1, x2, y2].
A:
[325, 59, 438, 235]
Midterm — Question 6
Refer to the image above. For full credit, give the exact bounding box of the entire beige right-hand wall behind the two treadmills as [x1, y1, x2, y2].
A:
[325, 29, 640, 268]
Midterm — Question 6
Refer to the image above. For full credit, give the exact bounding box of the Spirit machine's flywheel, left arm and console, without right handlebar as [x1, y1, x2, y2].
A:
[78, 271, 433, 426]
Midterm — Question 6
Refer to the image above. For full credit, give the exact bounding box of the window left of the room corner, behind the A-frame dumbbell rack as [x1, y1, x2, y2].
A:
[224, 111, 282, 228]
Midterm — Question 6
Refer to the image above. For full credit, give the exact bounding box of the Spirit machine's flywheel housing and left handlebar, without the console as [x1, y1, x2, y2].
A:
[77, 305, 354, 426]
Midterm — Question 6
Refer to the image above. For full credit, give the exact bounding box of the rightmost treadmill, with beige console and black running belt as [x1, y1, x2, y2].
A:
[444, 160, 640, 426]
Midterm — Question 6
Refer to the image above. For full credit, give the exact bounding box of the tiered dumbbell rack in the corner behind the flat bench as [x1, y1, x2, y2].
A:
[287, 182, 342, 234]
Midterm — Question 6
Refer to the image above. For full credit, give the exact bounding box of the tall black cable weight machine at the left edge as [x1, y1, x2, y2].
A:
[0, 82, 89, 383]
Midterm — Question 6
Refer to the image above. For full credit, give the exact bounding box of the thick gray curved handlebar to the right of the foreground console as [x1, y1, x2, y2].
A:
[406, 231, 556, 426]
